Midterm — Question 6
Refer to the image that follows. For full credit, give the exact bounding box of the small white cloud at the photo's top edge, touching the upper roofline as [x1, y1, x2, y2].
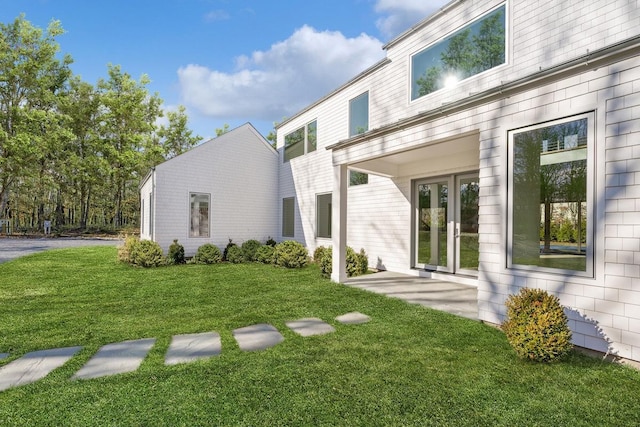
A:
[374, 0, 450, 38]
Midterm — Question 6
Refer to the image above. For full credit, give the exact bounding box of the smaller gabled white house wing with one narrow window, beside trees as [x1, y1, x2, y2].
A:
[140, 124, 279, 255]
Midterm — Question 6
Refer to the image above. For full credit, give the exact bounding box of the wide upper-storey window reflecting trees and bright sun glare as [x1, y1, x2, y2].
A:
[411, 6, 505, 100]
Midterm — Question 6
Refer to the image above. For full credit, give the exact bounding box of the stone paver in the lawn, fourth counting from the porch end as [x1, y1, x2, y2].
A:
[164, 332, 222, 365]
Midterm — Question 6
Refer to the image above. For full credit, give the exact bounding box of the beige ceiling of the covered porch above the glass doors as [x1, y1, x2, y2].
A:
[348, 132, 480, 178]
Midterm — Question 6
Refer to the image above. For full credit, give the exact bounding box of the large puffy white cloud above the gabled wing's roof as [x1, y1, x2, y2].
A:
[178, 26, 384, 121]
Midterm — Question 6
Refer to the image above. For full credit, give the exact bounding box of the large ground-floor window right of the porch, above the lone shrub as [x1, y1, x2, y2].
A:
[509, 114, 594, 273]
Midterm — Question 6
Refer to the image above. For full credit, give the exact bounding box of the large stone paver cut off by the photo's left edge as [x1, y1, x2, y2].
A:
[0, 347, 82, 391]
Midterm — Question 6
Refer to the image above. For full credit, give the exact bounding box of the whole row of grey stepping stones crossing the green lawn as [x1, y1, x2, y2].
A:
[0, 312, 370, 392]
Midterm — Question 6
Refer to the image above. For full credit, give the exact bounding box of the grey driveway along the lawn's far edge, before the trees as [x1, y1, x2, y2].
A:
[0, 237, 122, 264]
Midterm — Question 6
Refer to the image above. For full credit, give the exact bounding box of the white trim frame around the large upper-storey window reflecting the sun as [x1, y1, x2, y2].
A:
[408, 1, 510, 104]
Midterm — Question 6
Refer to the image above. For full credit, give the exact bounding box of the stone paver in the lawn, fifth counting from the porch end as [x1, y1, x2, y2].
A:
[72, 338, 156, 379]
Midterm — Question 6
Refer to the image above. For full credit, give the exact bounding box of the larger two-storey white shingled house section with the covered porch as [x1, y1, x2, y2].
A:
[143, 0, 640, 361]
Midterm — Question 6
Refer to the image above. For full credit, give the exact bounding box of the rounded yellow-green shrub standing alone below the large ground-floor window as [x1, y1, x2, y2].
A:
[502, 288, 573, 362]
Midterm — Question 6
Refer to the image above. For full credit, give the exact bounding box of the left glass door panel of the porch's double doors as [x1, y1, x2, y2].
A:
[416, 181, 449, 270]
